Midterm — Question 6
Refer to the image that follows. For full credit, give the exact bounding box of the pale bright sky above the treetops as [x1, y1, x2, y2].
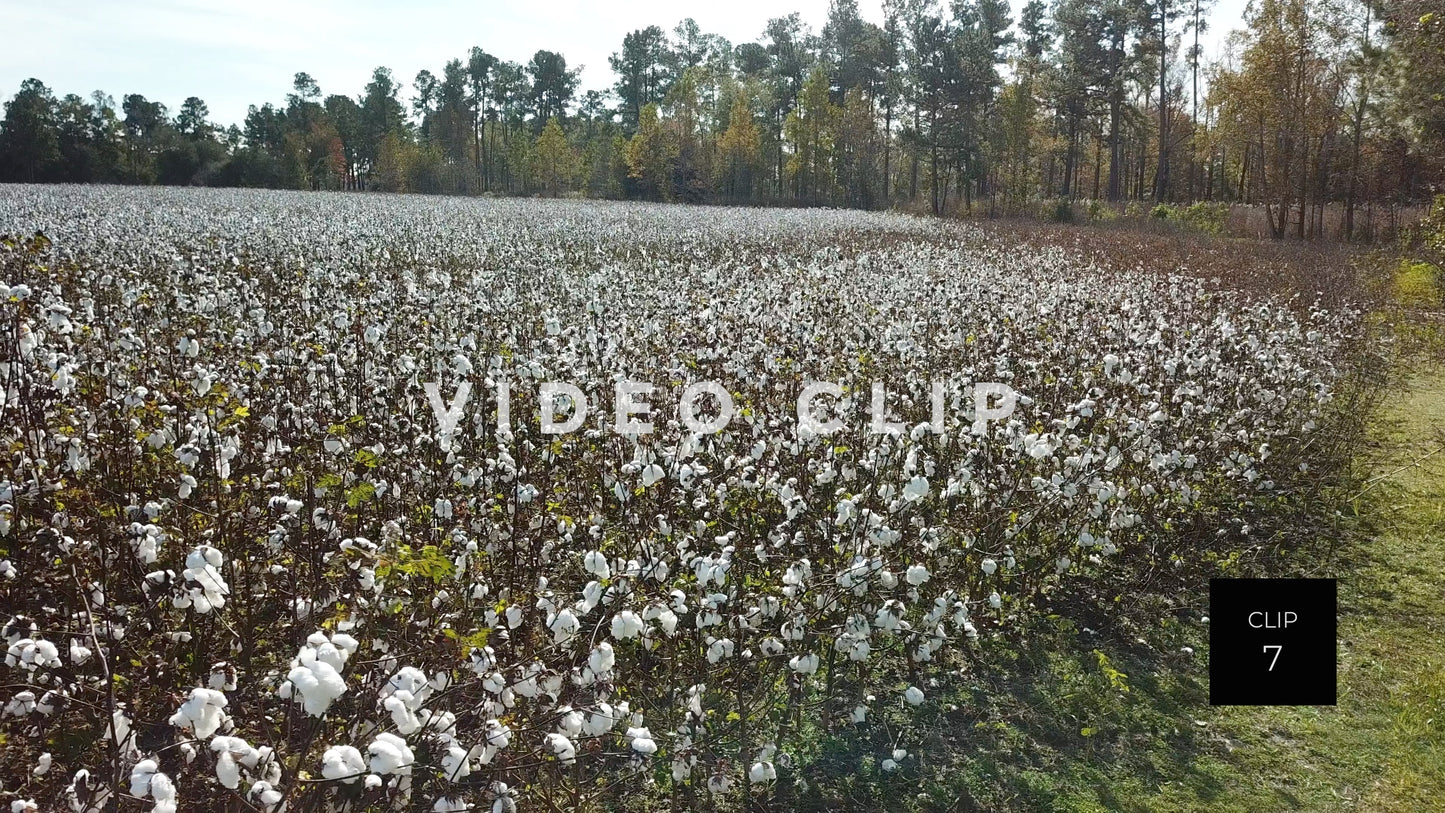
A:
[0, 0, 1247, 126]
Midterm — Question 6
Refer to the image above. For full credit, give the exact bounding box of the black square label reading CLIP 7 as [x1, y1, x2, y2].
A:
[1209, 579, 1338, 706]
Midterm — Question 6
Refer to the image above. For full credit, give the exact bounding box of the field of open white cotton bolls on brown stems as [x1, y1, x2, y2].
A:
[0, 186, 1360, 813]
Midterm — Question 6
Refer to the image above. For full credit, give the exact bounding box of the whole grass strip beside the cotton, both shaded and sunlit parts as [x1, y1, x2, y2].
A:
[826, 373, 1445, 813]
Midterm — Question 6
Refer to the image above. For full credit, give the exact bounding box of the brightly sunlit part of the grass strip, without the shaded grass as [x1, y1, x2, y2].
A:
[1075, 374, 1445, 812]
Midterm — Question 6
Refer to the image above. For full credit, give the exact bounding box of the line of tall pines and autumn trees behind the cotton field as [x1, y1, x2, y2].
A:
[0, 0, 1445, 237]
